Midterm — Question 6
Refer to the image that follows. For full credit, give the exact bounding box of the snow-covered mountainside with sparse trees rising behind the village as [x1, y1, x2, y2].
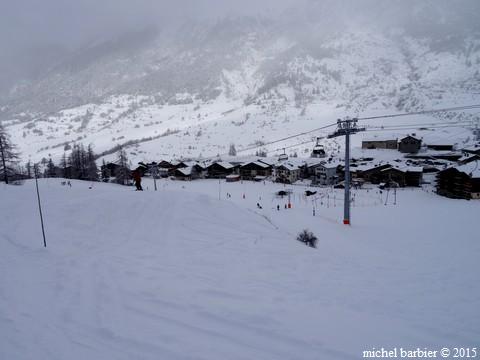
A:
[0, 0, 480, 159]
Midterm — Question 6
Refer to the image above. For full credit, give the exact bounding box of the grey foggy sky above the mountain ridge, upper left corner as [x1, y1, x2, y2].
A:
[0, 0, 294, 90]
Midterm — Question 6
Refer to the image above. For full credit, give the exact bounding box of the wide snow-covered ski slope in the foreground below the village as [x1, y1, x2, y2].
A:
[0, 179, 480, 360]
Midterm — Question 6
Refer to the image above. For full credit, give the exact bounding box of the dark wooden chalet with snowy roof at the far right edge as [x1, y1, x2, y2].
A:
[437, 160, 480, 200]
